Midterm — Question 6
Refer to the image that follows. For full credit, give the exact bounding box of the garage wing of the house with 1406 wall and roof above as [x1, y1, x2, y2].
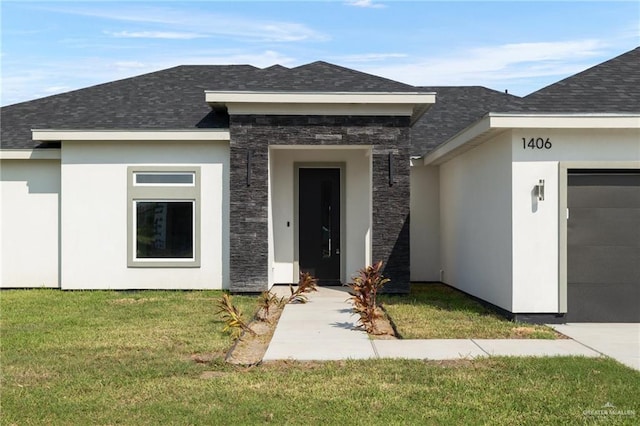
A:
[411, 49, 640, 322]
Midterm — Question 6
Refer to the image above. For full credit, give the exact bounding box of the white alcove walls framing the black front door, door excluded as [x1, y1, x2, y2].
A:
[269, 147, 371, 285]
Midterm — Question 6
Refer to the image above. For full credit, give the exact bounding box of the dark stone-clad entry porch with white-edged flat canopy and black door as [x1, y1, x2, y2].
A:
[219, 92, 435, 293]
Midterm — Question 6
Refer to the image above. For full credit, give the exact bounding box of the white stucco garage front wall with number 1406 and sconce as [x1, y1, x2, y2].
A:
[512, 129, 640, 313]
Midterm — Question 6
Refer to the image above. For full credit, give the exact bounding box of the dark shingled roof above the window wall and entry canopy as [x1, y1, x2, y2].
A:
[0, 62, 415, 149]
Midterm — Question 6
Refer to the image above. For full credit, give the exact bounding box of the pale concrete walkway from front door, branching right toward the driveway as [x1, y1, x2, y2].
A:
[263, 287, 637, 368]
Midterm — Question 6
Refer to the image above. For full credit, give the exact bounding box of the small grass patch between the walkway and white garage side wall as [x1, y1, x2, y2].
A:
[378, 284, 557, 339]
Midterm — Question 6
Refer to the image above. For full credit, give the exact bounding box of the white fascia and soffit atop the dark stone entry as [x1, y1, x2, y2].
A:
[205, 90, 436, 123]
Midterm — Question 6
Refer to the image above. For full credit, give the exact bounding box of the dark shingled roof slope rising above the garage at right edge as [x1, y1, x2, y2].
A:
[524, 47, 640, 113]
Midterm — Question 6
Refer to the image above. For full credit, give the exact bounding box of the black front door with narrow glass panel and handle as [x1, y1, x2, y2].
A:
[298, 168, 340, 285]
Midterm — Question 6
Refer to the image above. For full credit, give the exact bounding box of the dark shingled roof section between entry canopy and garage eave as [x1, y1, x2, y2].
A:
[411, 86, 522, 156]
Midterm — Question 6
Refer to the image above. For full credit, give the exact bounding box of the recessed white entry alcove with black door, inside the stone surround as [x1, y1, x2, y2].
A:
[268, 146, 372, 287]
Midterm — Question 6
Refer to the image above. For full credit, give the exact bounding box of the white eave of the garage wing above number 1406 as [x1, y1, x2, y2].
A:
[424, 113, 640, 165]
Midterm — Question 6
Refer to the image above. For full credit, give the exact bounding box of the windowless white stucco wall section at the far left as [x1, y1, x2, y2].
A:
[0, 160, 60, 288]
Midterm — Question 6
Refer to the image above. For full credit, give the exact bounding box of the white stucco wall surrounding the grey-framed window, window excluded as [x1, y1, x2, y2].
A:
[61, 141, 229, 289]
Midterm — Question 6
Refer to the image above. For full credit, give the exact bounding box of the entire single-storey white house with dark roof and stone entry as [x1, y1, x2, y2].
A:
[0, 49, 640, 322]
